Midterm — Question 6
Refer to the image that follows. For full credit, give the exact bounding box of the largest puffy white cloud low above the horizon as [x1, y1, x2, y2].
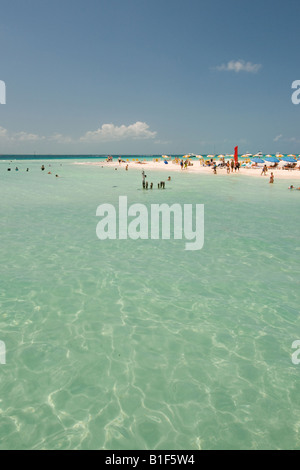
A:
[80, 121, 157, 142]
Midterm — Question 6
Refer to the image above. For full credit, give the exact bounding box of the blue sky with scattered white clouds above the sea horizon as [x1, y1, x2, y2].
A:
[0, 0, 300, 154]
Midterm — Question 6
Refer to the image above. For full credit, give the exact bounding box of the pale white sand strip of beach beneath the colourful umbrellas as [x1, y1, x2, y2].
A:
[75, 161, 300, 180]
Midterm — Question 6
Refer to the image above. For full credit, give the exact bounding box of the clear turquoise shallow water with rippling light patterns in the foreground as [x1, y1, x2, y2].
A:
[0, 160, 300, 450]
